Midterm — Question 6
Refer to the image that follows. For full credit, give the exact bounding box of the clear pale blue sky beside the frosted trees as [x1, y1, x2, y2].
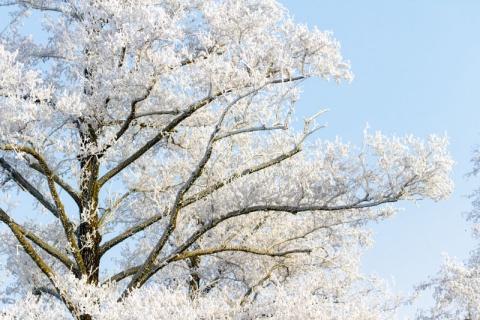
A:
[0, 0, 480, 318]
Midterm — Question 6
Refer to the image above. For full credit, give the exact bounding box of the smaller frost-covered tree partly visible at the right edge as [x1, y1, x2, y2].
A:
[417, 147, 480, 319]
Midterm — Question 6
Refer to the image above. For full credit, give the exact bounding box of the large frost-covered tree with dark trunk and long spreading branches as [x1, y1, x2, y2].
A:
[0, 0, 452, 319]
